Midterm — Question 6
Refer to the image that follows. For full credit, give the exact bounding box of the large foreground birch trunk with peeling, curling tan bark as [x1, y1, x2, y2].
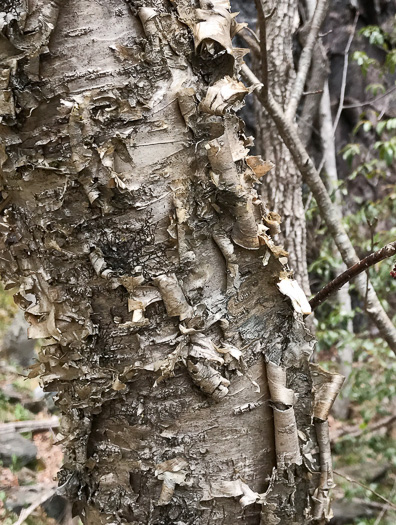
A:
[0, 0, 342, 525]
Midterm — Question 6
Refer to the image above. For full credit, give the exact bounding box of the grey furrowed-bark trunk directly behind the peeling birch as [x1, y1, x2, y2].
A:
[255, 0, 310, 295]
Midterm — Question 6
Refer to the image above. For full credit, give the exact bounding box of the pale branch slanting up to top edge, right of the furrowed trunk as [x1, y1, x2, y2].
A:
[286, 0, 329, 120]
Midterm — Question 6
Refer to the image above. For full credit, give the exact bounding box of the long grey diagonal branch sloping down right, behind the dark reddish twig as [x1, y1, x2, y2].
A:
[241, 65, 396, 354]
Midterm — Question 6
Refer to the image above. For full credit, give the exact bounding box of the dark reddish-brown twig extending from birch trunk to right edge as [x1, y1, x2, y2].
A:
[309, 241, 396, 310]
